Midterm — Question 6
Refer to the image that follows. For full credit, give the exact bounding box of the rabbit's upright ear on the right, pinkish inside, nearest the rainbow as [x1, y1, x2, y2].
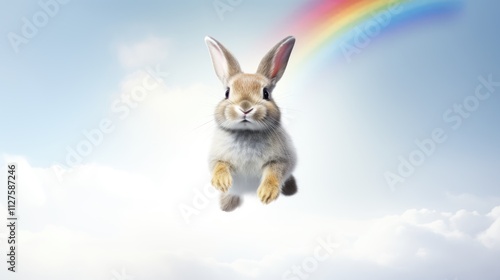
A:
[257, 36, 295, 85]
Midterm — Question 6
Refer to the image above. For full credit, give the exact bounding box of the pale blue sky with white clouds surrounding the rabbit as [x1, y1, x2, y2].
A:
[0, 0, 500, 280]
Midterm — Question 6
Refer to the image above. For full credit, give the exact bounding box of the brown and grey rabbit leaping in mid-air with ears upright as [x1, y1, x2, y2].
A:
[205, 36, 297, 212]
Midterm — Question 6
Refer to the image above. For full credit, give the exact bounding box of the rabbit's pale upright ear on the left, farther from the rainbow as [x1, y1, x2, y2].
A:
[205, 36, 241, 85]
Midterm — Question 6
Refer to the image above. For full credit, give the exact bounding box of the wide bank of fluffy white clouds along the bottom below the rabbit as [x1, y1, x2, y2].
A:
[0, 157, 500, 280]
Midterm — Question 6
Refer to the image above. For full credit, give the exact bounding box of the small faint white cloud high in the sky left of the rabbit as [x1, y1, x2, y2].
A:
[118, 37, 169, 68]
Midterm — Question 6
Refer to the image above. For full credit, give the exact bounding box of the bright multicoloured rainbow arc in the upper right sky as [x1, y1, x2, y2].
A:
[274, 0, 463, 65]
